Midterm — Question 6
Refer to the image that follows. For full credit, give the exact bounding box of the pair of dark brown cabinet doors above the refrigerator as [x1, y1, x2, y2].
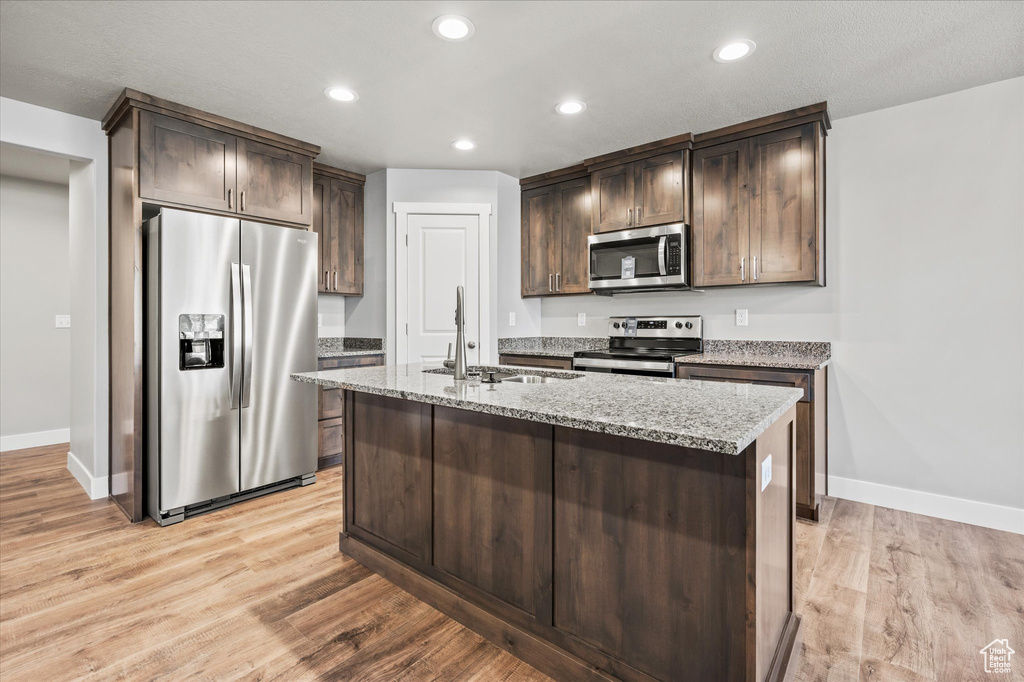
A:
[139, 111, 312, 226]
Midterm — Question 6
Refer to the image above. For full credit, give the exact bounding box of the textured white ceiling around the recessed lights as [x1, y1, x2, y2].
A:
[0, 0, 1024, 177]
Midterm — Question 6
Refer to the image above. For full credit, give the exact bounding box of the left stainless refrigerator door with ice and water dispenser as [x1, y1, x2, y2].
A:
[146, 209, 241, 511]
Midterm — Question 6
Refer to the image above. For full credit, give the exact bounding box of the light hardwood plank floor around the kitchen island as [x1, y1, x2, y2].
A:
[0, 445, 1024, 682]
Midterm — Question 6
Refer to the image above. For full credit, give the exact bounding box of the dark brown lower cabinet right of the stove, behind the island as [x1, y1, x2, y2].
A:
[676, 364, 828, 521]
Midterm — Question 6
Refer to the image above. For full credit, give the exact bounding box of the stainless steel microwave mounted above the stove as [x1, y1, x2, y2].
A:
[587, 222, 689, 294]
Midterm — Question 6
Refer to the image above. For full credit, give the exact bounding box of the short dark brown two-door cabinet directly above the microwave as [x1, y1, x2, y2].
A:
[591, 150, 689, 232]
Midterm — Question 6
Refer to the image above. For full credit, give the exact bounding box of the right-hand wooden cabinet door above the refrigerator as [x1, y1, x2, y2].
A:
[238, 137, 313, 225]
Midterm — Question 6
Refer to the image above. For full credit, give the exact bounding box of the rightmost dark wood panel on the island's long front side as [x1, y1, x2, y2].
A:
[554, 427, 753, 680]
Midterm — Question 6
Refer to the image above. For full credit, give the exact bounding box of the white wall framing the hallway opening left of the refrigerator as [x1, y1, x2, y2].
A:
[0, 97, 110, 499]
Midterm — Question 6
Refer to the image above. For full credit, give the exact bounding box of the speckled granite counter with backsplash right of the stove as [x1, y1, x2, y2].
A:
[679, 339, 831, 370]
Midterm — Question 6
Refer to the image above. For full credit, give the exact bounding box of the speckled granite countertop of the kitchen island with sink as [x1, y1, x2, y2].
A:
[292, 365, 803, 455]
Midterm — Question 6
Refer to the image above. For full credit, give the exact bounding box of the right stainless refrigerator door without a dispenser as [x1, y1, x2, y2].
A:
[241, 221, 317, 491]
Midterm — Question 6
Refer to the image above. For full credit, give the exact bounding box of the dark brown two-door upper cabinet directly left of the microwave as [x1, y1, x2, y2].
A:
[521, 177, 592, 296]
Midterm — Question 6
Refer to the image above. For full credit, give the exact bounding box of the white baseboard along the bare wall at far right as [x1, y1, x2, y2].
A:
[828, 476, 1024, 535]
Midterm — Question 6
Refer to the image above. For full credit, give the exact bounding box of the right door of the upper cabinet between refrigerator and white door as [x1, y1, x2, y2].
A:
[325, 179, 362, 296]
